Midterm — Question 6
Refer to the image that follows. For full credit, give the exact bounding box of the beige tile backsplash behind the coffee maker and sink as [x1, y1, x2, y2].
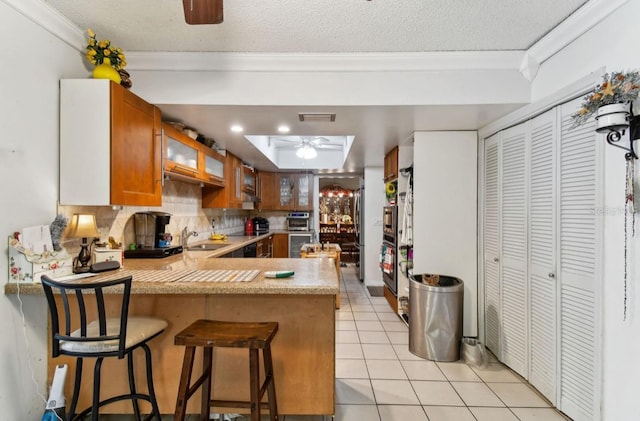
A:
[58, 180, 286, 251]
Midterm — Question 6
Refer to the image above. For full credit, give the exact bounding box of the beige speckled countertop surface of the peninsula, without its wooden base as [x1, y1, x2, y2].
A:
[4, 233, 339, 295]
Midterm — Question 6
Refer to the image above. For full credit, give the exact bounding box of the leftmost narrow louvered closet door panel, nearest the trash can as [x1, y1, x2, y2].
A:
[482, 134, 501, 358]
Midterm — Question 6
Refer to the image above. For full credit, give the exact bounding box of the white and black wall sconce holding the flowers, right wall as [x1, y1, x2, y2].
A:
[596, 102, 640, 161]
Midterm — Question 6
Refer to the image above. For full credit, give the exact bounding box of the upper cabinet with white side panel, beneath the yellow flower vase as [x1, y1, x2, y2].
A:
[60, 79, 162, 206]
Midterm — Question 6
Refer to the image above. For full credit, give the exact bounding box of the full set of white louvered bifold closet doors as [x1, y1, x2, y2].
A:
[481, 101, 602, 420]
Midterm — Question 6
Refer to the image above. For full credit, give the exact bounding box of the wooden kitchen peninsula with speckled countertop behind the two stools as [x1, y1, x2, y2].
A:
[5, 244, 339, 414]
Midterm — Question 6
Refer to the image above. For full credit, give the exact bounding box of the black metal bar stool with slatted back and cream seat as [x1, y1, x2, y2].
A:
[41, 275, 167, 421]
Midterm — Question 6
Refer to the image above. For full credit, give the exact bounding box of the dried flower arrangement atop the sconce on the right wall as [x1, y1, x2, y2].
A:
[571, 71, 640, 127]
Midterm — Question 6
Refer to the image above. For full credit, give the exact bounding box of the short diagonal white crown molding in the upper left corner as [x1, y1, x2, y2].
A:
[0, 0, 87, 53]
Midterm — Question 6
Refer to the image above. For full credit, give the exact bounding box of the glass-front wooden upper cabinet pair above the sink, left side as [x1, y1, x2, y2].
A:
[162, 124, 225, 186]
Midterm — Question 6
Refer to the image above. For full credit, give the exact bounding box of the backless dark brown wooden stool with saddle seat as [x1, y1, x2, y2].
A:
[174, 320, 278, 421]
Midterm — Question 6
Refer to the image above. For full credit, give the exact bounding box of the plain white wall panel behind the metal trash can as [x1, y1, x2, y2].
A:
[409, 131, 478, 336]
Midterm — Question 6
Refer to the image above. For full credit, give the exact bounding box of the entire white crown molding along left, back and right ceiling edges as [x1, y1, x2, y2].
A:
[8, 0, 629, 74]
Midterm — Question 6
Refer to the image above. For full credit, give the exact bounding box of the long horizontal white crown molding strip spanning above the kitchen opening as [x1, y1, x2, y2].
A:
[127, 51, 523, 72]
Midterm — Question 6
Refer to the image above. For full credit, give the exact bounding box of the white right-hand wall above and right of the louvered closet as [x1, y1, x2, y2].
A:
[533, 0, 640, 421]
